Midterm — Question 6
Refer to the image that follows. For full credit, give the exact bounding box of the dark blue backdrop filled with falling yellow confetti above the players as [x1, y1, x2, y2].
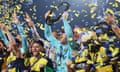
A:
[0, 0, 120, 37]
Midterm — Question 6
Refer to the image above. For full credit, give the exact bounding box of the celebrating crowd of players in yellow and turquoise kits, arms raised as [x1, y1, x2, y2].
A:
[0, 11, 120, 72]
